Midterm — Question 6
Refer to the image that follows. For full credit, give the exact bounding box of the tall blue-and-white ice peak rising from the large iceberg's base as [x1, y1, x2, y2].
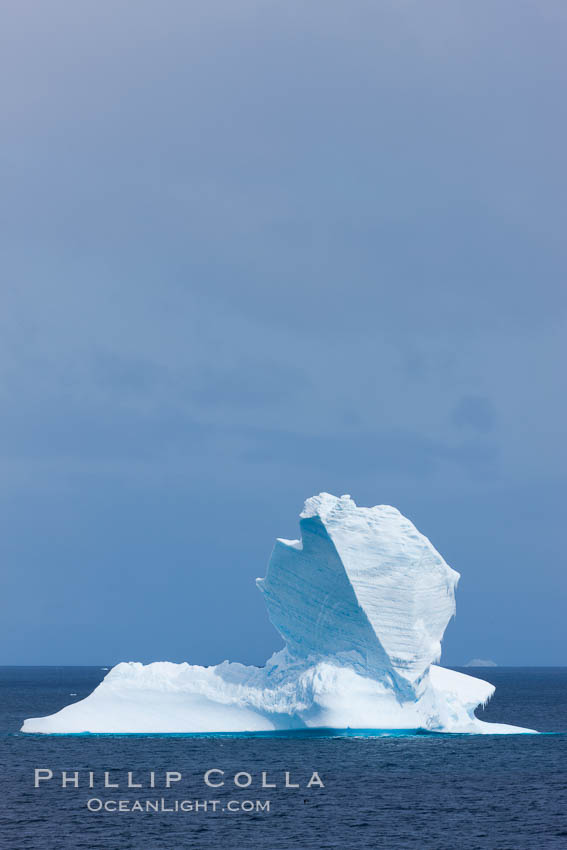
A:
[258, 493, 459, 700]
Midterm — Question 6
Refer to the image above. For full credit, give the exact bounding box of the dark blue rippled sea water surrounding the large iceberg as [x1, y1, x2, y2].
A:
[0, 667, 567, 850]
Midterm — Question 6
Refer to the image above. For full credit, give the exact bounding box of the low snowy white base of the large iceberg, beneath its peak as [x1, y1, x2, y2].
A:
[22, 649, 534, 734]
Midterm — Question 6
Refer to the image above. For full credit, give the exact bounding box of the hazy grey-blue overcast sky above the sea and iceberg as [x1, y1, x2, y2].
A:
[0, 0, 567, 665]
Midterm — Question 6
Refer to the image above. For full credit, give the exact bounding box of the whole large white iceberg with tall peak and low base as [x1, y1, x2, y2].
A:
[22, 493, 534, 734]
